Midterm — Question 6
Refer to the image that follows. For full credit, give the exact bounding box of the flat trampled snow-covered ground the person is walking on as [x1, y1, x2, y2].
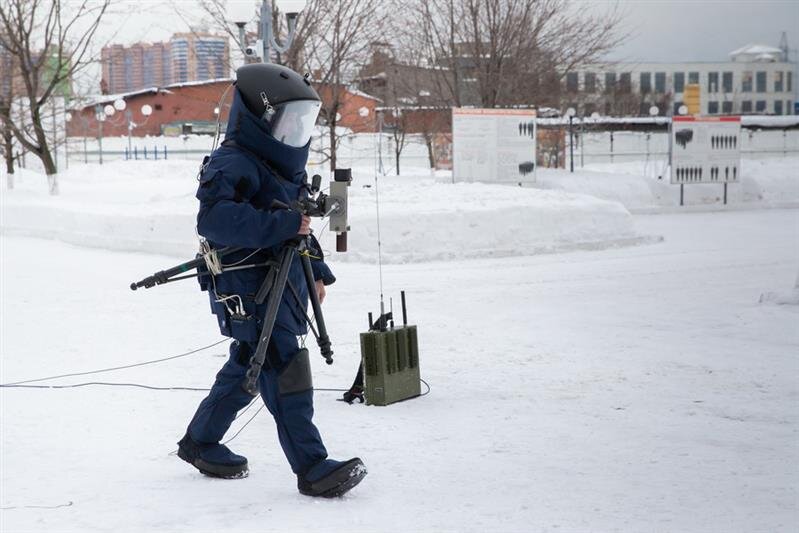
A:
[0, 206, 799, 532]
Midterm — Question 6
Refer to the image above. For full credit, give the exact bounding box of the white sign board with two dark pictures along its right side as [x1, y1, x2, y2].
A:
[452, 108, 537, 184]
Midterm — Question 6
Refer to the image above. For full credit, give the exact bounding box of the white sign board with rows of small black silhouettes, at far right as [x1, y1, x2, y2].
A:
[671, 117, 741, 183]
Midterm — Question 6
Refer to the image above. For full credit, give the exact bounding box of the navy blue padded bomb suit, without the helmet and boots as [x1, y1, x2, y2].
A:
[188, 89, 335, 474]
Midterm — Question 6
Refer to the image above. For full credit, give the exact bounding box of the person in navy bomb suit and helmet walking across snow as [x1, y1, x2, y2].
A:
[178, 63, 366, 497]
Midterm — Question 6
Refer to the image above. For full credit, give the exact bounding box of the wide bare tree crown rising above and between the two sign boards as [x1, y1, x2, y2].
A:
[400, 0, 622, 107]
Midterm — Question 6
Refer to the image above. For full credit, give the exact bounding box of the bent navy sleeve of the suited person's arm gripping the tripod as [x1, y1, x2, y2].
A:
[197, 170, 302, 248]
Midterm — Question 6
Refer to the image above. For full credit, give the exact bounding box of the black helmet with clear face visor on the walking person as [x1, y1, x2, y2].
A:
[236, 63, 322, 147]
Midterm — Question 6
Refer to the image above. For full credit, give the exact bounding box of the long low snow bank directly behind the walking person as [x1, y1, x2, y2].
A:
[0, 160, 648, 262]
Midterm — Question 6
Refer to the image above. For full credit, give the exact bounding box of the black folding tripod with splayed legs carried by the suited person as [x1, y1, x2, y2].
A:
[130, 235, 333, 396]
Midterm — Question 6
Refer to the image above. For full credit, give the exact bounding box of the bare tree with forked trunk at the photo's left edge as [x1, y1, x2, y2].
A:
[0, 0, 110, 194]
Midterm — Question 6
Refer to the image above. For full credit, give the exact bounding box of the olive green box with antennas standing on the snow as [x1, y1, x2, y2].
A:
[361, 326, 422, 405]
